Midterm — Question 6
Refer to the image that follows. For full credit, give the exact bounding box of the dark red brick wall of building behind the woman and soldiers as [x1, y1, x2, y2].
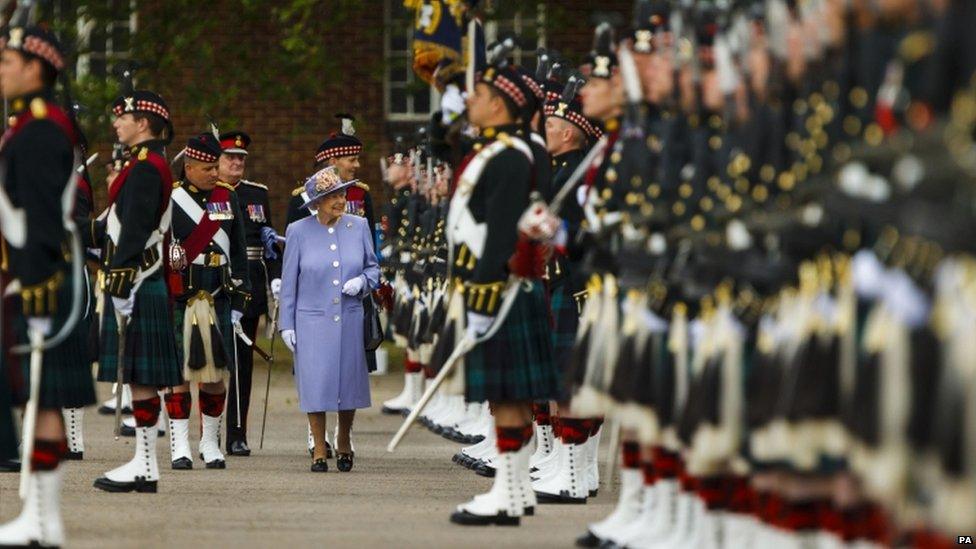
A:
[124, 0, 632, 230]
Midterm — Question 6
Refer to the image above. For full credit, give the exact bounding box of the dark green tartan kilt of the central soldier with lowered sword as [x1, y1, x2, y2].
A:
[465, 281, 560, 402]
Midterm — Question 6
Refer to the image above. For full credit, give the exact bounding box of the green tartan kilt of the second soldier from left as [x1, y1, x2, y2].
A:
[98, 272, 183, 387]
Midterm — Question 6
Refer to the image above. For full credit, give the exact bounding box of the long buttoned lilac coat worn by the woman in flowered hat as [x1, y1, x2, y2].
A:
[279, 214, 380, 413]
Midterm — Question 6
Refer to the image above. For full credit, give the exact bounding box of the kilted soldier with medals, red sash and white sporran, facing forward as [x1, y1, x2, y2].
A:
[166, 134, 250, 470]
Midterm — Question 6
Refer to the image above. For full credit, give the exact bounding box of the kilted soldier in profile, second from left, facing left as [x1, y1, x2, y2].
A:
[92, 90, 183, 492]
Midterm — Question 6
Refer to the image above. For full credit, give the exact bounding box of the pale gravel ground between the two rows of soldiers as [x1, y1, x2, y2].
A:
[0, 346, 615, 549]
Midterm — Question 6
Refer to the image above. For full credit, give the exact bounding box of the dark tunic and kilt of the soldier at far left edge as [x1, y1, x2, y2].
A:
[0, 92, 95, 418]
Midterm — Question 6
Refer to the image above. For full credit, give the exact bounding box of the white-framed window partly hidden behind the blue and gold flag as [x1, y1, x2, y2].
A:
[383, 0, 546, 122]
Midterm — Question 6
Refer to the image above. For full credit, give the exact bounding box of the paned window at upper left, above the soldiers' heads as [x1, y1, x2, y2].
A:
[77, 0, 136, 78]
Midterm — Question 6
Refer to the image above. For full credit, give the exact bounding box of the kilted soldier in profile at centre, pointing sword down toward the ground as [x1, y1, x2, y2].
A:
[447, 60, 559, 525]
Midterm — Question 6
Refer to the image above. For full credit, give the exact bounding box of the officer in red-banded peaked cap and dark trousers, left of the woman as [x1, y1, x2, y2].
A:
[218, 131, 281, 456]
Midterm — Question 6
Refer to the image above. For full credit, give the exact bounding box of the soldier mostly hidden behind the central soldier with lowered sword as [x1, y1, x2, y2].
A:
[530, 76, 603, 503]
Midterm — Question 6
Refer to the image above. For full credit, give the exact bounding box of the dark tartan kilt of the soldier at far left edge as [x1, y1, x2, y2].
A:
[11, 265, 95, 409]
